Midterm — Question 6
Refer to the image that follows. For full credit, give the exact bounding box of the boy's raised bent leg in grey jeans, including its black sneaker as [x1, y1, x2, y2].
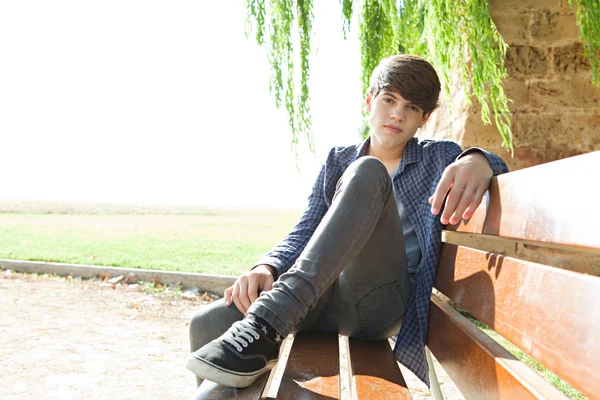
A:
[188, 157, 409, 386]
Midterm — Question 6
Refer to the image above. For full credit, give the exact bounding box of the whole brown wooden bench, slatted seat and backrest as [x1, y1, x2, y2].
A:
[194, 152, 600, 400]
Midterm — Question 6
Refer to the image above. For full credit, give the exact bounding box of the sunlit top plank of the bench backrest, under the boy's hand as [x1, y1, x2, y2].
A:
[448, 151, 600, 249]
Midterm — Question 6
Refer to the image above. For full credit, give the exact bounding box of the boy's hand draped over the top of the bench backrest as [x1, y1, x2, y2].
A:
[429, 152, 494, 225]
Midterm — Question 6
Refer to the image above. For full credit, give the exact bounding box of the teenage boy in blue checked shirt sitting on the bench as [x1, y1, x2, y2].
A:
[187, 55, 508, 387]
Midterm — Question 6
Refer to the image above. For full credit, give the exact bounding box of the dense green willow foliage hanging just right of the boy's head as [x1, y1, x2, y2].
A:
[418, 0, 513, 151]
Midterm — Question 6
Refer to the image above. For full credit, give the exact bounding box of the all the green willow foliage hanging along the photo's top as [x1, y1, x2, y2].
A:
[245, 0, 600, 152]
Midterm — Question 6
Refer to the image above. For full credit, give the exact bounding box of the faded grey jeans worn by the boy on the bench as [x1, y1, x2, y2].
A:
[190, 157, 411, 382]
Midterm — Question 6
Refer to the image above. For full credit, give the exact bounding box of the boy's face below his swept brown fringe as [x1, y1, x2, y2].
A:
[365, 90, 431, 152]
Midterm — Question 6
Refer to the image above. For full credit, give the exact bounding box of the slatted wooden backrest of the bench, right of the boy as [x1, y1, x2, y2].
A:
[428, 152, 600, 399]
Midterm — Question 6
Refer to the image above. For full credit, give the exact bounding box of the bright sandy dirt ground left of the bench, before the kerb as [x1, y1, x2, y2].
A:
[0, 271, 201, 400]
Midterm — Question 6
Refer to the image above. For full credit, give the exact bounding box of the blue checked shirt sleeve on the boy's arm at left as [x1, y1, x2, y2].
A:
[255, 150, 333, 279]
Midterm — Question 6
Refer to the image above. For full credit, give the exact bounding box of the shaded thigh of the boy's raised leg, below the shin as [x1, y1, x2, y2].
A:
[296, 187, 411, 339]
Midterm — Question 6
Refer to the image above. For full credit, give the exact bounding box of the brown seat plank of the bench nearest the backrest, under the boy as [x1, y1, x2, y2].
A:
[350, 339, 412, 400]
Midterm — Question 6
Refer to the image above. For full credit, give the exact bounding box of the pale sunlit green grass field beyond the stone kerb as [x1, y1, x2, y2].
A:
[0, 211, 299, 275]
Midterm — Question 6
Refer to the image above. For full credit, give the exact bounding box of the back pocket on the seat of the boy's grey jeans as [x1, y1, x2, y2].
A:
[354, 279, 406, 339]
